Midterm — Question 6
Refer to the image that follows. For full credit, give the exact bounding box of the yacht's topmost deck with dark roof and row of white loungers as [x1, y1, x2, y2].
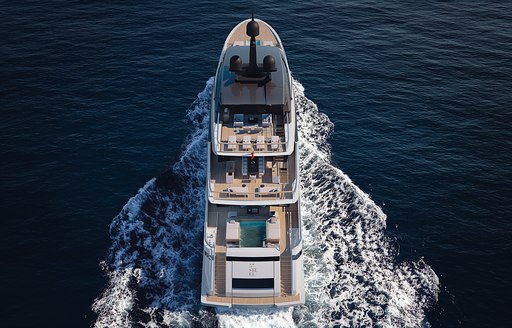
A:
[211, 20, 296, 156]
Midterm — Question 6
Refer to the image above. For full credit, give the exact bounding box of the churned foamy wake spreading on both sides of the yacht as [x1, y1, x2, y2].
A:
[92, 78, 439, 327]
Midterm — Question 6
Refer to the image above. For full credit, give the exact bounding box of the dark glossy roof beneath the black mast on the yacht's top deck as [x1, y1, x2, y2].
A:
[219, 46, 290, 109]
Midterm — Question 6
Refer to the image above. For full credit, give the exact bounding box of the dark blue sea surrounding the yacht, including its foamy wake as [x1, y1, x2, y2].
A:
[0, 0, 512, 327]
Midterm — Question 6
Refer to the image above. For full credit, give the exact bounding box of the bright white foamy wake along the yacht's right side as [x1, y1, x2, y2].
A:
[295, 83, 439, 327]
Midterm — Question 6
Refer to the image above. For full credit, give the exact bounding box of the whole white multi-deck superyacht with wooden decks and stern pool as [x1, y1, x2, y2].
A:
[201, 17, 305, 307]
